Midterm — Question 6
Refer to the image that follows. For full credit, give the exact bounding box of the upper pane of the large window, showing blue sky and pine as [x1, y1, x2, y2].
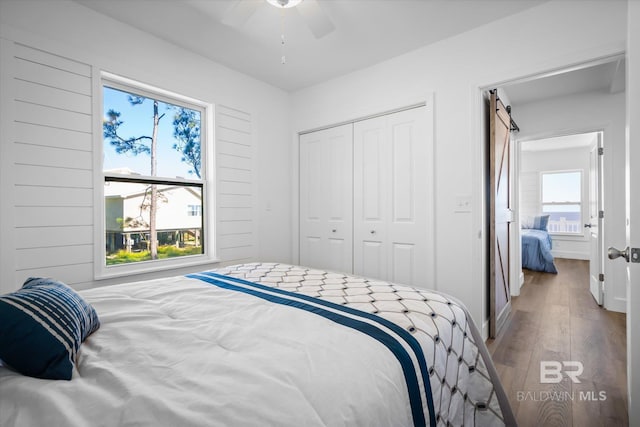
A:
[103, 86, 201, 179]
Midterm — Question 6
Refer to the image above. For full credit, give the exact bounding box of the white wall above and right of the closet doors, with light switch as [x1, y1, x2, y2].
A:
[292, 1, 626, 332]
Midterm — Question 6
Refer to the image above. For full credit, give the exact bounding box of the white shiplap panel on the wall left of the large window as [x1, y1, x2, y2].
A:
[10, 44, 93, 284]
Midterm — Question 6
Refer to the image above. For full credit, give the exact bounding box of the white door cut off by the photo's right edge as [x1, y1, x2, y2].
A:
[618, 1, 640, 426]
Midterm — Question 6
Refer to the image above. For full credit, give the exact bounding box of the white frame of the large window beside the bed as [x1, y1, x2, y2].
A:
[94, 71, 219, 280]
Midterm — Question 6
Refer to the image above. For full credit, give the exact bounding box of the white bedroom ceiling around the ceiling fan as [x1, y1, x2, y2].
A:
[75, 0, 544, 91]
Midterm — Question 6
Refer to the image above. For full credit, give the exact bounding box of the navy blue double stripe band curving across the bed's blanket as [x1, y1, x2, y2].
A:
[186, 272, 436, 426]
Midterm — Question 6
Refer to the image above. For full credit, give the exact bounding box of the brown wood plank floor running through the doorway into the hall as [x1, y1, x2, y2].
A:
[487, 259, 628, 427]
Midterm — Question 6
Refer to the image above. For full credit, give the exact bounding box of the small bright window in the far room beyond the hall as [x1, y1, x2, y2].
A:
[541, 171, 583, 235]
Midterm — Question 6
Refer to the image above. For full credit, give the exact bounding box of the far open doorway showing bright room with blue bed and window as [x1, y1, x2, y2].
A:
[514, 131, 605, 306]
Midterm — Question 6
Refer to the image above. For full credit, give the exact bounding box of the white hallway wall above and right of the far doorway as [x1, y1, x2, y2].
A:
[513, 92, 627, 312]
